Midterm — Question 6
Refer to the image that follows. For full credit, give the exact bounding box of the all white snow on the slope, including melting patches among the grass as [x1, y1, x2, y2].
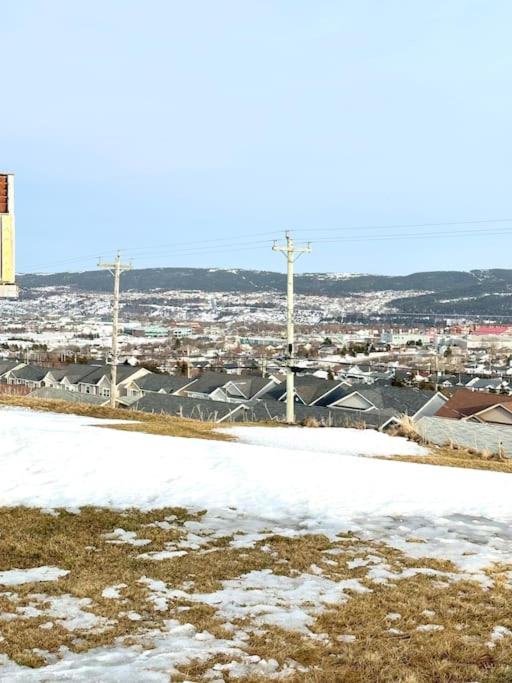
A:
[0, 408, 512, 681]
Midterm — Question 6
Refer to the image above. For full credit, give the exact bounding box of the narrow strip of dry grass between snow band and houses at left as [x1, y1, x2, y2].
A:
[0, 395, 232, 441]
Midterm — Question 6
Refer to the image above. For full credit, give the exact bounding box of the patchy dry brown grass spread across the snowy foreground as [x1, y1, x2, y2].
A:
[0, 508, 512, 683]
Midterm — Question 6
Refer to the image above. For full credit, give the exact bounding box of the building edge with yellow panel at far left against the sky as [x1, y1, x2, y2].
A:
[0, 173, 18, 297]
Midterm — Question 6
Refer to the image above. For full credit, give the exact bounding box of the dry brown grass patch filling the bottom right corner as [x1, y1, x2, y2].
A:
[237, 576, 512, 683]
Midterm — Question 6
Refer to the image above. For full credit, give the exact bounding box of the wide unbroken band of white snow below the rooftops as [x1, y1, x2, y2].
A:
[0, 409, 512, 566]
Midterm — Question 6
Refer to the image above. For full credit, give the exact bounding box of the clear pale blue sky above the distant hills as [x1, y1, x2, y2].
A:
[0, 0, 512, 274]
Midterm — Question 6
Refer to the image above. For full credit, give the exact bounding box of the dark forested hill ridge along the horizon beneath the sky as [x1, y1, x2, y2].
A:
[19, 268, 512, 315]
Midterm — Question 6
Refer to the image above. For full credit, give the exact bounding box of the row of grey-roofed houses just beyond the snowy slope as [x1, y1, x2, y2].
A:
[0, 361, 446, 428]
